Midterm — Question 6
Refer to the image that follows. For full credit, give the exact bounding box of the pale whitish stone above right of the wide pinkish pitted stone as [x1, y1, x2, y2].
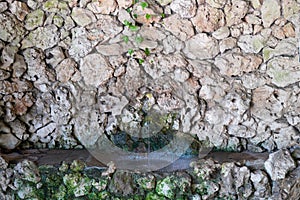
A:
[238, 35, 266, 53]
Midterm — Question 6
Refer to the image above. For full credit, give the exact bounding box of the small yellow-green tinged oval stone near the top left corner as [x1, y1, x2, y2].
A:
[25, 9, 45, 30]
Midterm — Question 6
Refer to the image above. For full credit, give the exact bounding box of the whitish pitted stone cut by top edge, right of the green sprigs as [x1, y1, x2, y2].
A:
[170, 0, 197, 18]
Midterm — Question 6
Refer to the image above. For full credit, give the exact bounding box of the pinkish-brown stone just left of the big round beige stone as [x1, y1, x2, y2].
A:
[55, 58, 77, 83]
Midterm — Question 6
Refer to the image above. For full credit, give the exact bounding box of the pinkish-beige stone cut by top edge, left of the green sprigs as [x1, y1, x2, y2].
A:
[87, 0, 117, 15]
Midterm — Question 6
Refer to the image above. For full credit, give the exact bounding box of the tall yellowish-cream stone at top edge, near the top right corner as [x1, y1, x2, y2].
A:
[261, 0, 280, 27]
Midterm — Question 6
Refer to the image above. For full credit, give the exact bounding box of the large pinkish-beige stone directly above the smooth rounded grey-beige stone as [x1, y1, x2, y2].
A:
[192, 5, 225, 32]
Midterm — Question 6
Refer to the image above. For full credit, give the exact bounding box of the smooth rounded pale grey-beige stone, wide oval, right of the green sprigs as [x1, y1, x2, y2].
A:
[183, 33, 219, 59]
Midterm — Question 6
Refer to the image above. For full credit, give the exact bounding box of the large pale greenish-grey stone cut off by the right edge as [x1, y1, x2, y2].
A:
[267, 56, 300, 87]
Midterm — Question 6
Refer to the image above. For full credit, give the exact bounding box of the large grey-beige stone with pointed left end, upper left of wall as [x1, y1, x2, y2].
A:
[22, 25, 59, 50]
